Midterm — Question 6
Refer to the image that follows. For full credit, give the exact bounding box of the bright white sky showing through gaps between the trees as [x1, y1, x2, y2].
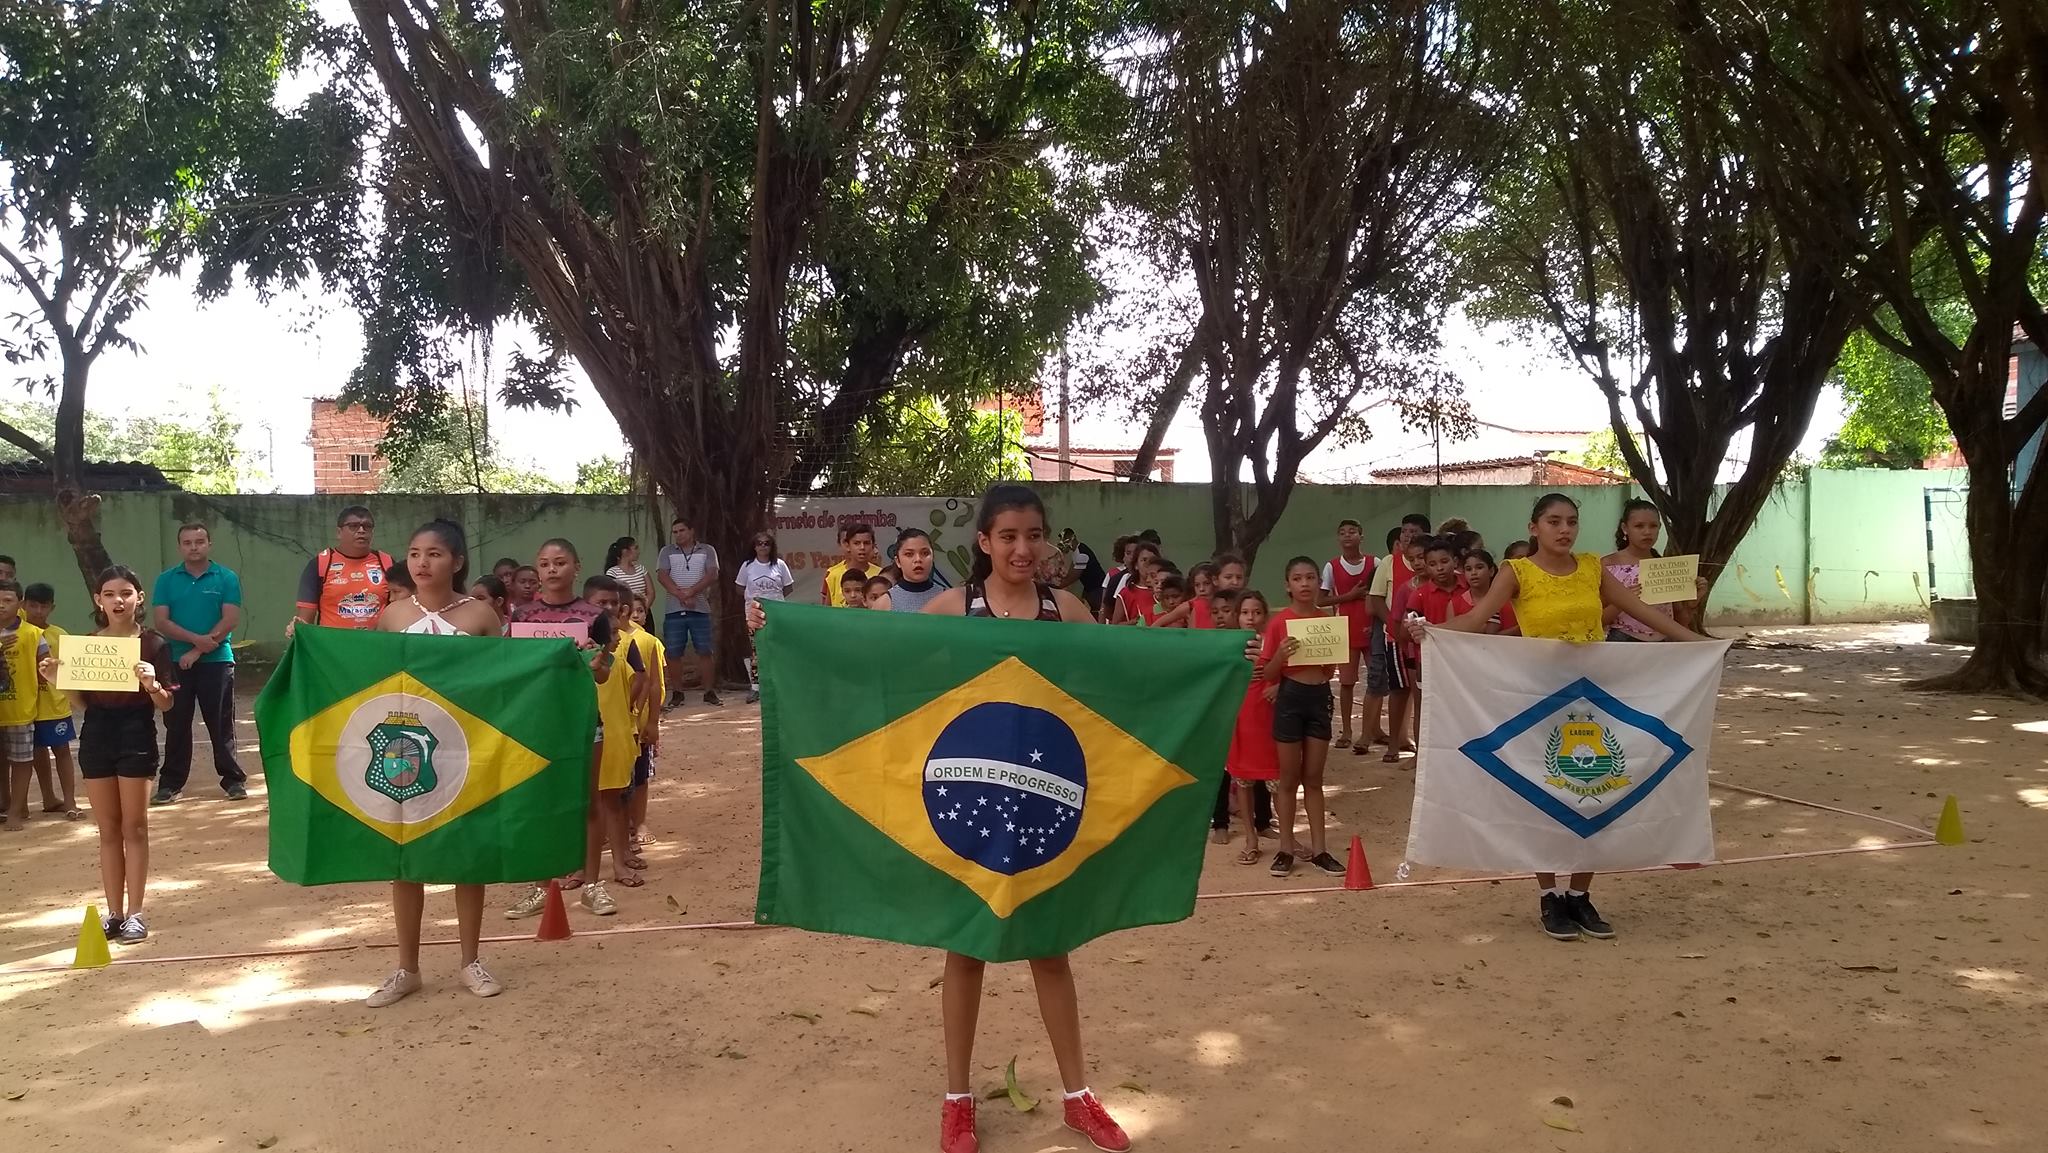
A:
[16, 262, 1841, 492]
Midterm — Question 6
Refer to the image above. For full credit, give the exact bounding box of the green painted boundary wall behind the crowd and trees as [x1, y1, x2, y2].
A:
[0, 469, 1968, 657]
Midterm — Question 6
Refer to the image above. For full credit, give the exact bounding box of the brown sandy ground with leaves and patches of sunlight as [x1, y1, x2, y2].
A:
[0, 627, 2048, 1153]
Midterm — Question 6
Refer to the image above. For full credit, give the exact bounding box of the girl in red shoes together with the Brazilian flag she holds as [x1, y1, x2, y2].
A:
[748, 483, 1255, 1153]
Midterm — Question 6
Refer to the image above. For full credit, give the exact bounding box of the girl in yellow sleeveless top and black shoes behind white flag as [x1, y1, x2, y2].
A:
[1407, 492, 1706, 940]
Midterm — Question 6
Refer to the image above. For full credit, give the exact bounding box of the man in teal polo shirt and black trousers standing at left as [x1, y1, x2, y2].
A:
[150, 524, 250, 805]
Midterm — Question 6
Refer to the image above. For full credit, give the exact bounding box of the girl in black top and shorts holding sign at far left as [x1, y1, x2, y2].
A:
[37, 565, 178, 944]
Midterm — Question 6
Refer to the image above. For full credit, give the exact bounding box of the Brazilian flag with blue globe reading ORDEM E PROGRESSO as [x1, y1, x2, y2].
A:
[754, 604, 1251, 960]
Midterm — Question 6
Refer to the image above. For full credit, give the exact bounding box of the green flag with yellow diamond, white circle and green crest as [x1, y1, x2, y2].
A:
[256, 627, 598, 885]
